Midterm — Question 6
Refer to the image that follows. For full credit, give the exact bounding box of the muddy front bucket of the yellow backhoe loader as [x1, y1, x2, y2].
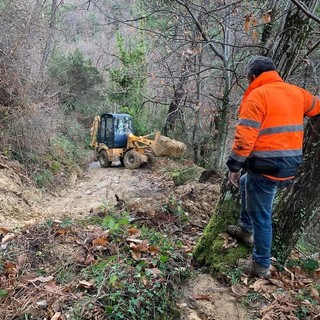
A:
[151, 132, 187, 158]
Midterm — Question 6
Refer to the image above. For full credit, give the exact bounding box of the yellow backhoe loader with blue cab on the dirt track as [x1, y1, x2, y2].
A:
[90, 113, 186, 169]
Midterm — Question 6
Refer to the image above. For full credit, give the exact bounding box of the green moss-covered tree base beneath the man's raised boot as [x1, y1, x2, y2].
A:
[194, 179, 250, 272]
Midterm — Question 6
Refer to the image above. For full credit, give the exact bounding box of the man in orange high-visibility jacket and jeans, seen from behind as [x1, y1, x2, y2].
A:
[227, 56, 320, 277]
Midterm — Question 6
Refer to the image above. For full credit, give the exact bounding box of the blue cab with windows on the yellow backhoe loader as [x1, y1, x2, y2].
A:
[98, 113, 133, 149]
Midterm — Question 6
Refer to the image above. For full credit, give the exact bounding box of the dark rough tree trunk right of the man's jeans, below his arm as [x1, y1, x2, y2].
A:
[274, 116, 320, 262]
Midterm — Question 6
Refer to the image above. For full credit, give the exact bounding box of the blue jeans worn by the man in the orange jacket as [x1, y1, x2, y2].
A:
[239, 172, 292, 267]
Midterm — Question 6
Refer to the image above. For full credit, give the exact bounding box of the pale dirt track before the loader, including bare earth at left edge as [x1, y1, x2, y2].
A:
[0, 162, 158, 228]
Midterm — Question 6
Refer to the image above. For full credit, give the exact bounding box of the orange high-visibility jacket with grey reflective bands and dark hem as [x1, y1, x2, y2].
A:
[227, 71, 320, 179]
